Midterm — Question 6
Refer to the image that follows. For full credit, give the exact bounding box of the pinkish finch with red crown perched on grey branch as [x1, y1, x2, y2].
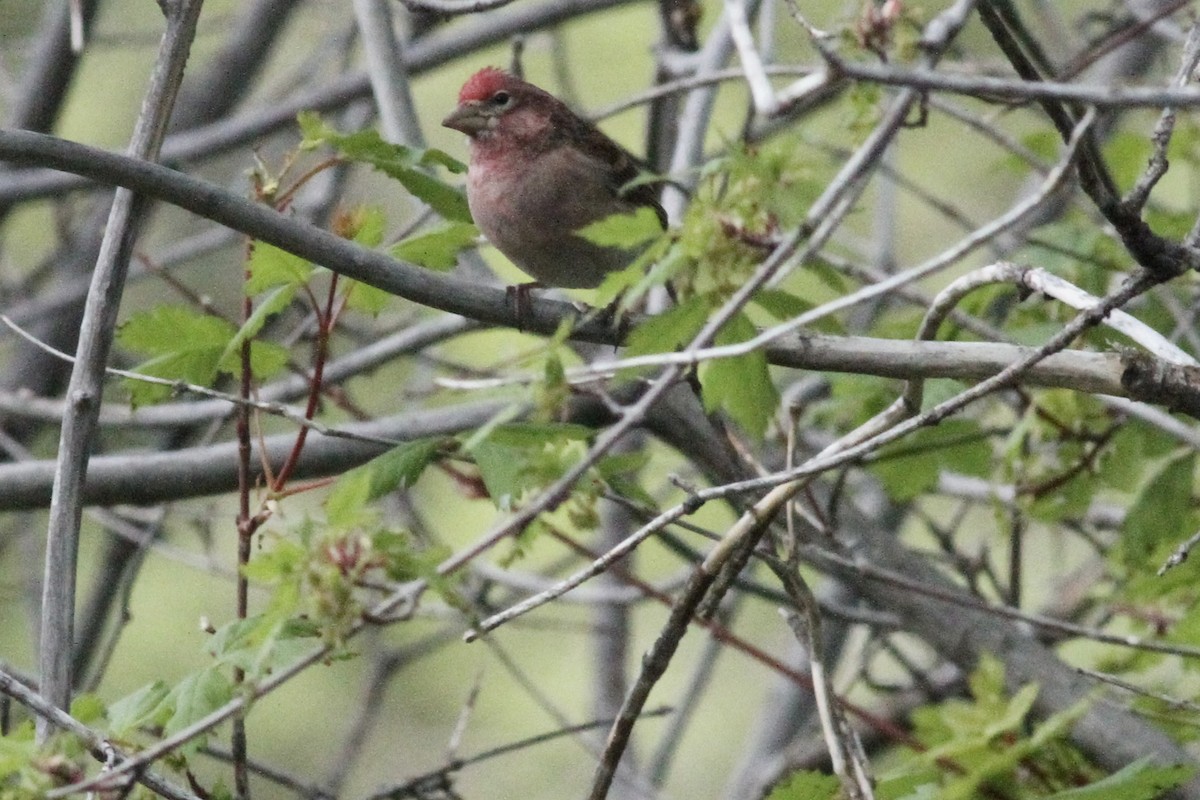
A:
[442, 67, 667, 291]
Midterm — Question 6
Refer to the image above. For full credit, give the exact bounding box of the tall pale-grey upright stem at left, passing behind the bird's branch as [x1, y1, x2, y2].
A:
[37, 0, 203, 741]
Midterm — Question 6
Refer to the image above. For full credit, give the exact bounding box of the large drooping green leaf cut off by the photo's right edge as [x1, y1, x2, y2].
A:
[1121, 450, 1195, 566]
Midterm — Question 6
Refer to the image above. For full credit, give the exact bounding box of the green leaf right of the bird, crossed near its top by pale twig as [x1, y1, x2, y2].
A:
[700, 314, 779, 439]
